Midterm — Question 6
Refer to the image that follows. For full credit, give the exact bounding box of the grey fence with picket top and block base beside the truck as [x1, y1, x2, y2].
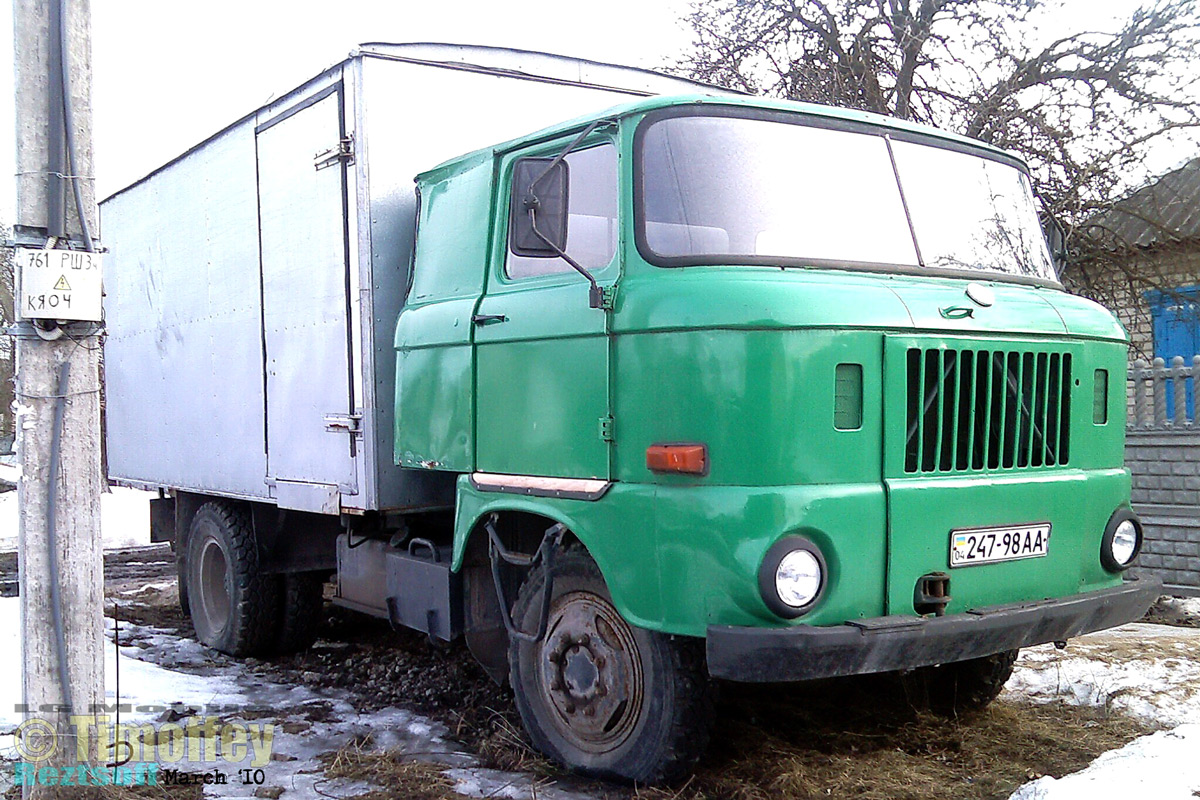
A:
[1126, 355, 1200, 595]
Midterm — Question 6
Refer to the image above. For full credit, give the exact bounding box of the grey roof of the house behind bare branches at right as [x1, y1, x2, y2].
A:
[1088, 158, 1200, 248]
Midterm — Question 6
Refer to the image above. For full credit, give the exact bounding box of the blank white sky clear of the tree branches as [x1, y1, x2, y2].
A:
[0, 0, 1189, 222]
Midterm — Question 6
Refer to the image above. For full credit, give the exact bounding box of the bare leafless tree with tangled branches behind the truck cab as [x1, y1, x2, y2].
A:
[676, 0, 1200, 296]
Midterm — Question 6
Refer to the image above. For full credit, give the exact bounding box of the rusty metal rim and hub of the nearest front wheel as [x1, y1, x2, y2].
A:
[540, 593, 643, 752]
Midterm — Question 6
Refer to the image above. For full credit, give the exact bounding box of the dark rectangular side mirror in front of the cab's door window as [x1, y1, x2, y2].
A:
[509, 158, 570, 258]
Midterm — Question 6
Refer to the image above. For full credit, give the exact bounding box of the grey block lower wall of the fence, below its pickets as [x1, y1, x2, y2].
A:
[1126, 431, 1200, 593]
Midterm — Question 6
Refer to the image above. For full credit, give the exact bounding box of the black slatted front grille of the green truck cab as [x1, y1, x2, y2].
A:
[905, 348, 1072, 473]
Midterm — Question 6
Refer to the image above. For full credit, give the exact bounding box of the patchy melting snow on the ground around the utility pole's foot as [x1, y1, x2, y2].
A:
[0, 597, 588, 800]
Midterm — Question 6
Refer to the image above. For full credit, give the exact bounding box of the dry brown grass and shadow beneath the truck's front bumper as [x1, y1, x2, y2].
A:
[636, 680, 1148, 800]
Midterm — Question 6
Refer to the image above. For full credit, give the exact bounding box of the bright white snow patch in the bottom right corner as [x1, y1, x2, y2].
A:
[1009, 723, 1200, 800]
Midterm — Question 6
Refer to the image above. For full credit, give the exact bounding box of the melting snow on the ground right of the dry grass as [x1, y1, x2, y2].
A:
[1001, 622, 1200, 800]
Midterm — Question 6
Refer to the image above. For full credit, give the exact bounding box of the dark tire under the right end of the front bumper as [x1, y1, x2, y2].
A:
[902, 650, 1020, 716]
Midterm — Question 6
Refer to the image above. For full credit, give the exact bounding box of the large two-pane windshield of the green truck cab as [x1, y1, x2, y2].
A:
[637, 116, 1055, 281]
